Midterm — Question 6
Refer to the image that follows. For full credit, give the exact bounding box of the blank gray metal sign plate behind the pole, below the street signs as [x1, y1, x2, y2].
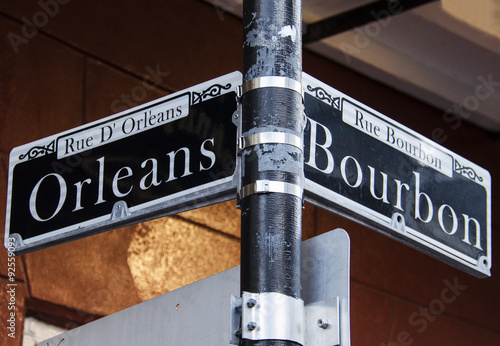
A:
[38, 229, 350, 346]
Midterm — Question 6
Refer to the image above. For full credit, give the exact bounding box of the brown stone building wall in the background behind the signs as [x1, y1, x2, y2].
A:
[0, 0, 500, 346]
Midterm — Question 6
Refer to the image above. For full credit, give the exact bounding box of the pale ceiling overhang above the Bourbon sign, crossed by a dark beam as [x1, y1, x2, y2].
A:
[208, 0, 500, 132]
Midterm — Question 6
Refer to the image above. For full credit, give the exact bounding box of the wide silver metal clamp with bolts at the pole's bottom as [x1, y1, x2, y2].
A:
[241, 292, 305, 345]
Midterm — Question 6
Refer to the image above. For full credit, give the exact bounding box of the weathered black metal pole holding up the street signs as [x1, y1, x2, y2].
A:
[240, 0, 304, 346]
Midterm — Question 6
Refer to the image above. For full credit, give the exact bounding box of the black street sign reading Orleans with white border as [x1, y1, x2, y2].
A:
[5, 72, 242, 254]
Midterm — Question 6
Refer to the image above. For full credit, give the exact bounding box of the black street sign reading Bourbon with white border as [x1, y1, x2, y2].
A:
[302, 74, 491, 277]
